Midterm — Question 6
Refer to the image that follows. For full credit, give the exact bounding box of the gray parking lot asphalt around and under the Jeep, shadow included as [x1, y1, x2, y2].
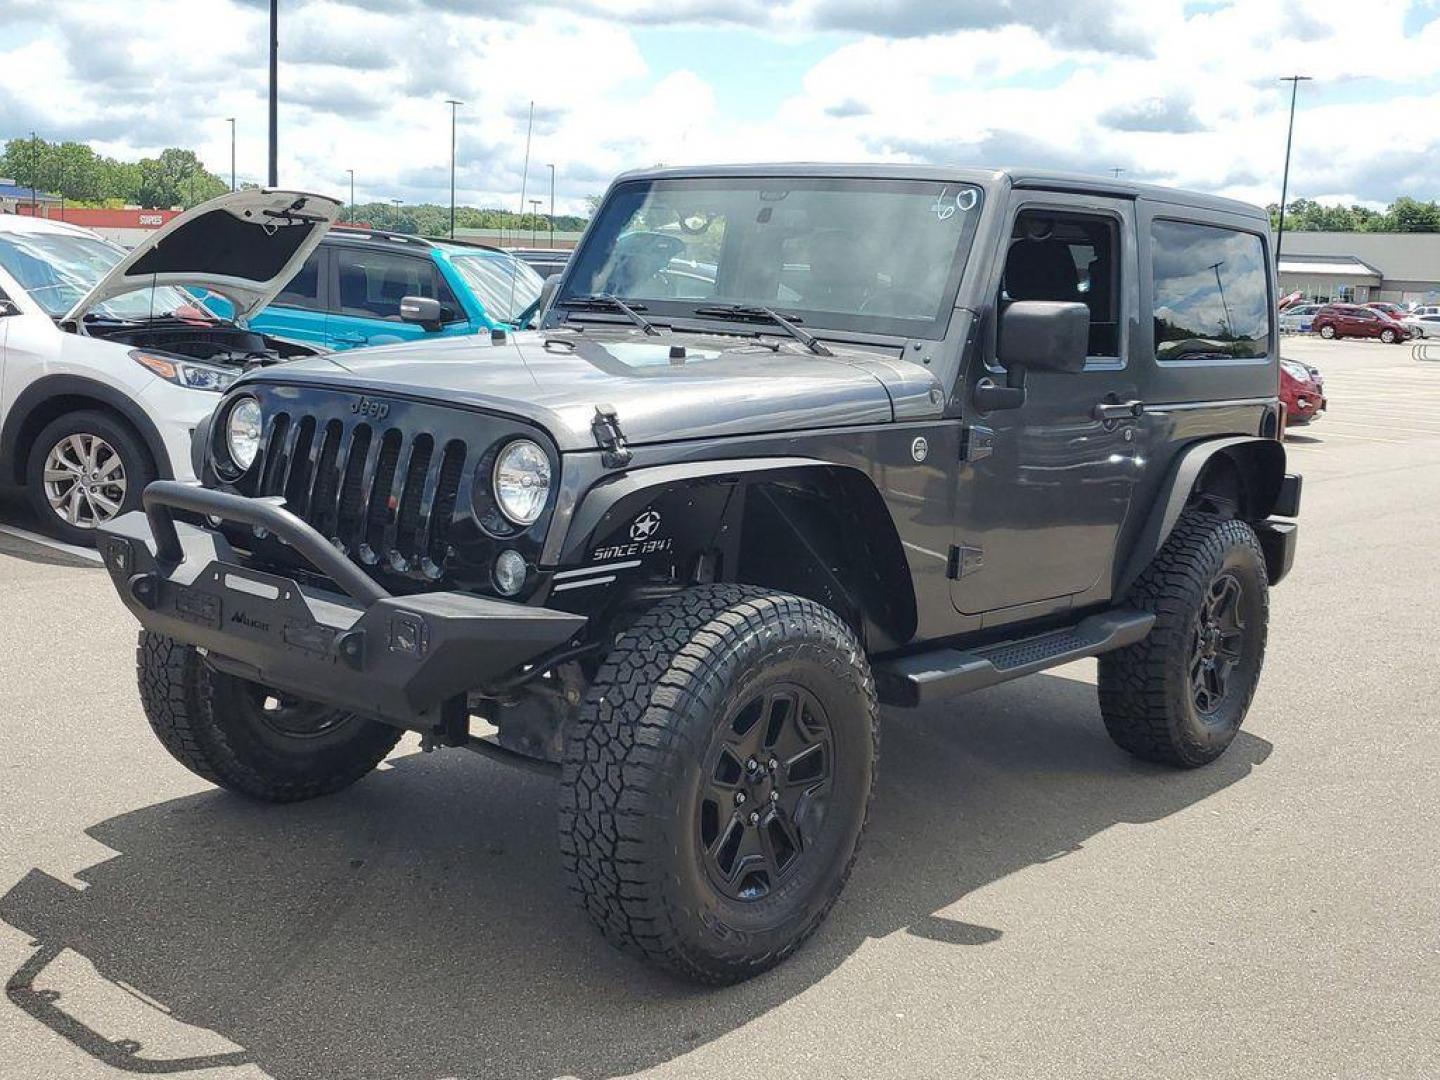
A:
[0, 340, 1440, 1080]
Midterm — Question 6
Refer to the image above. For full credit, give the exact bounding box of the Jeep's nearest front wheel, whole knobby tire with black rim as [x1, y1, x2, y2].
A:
[560, 586, 878, 984]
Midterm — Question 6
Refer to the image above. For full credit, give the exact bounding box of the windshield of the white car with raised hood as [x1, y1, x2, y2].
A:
[0, 232, 209, 321]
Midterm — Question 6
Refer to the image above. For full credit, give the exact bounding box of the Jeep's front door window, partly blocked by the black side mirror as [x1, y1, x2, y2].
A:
[1001, 210, 1120, 356]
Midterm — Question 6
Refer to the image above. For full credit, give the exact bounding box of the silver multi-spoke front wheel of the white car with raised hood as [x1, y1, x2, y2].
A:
[24, 412, 156, 547]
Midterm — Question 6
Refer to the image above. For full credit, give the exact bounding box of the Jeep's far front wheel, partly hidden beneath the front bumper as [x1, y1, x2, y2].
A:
[135, 631, 400, 802]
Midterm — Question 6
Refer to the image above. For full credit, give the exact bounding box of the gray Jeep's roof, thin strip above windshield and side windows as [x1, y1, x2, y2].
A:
[616, 161, 1269, 222]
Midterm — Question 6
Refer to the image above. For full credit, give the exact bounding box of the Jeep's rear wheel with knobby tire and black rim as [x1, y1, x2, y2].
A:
[1099, 511, 1270, 768]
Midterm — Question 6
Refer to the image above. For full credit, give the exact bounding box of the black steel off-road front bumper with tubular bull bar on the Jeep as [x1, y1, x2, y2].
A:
[99, 481, 586, 732]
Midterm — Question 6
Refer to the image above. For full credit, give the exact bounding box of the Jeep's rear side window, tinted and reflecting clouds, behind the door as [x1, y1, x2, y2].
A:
[1151, 220, 1270, 360]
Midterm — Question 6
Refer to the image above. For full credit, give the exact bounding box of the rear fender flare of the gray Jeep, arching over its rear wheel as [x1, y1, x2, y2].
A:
[1115, 435, 1284, 596]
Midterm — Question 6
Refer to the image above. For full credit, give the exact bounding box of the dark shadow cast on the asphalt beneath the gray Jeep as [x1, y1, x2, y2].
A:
[0, 675, 1272, 1080]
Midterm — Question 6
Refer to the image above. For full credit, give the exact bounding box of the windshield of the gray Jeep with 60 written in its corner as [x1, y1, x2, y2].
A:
[560, 177, 981, 337]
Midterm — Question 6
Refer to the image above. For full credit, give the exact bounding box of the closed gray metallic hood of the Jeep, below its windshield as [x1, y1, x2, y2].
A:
[244, 330, 943, 451]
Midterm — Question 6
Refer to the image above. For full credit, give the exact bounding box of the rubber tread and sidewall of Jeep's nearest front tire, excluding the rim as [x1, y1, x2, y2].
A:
[559, 585, 878, 985]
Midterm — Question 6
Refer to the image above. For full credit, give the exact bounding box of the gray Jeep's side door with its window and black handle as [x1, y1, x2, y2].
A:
[950, 190, 1143, 625]
